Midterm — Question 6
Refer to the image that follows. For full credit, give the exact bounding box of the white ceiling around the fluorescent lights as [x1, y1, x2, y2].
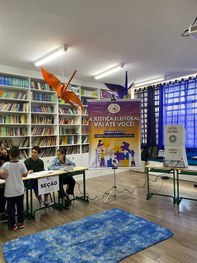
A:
[0, 0, 197, 86]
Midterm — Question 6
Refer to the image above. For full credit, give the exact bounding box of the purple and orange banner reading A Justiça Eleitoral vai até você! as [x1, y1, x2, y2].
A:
[88, 99, 141, 168]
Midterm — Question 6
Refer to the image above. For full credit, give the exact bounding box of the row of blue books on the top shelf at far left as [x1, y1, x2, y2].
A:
[0, 76, 29, 88]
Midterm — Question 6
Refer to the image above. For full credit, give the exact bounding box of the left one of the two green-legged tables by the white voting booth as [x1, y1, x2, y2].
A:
[146, 165, 177, 204]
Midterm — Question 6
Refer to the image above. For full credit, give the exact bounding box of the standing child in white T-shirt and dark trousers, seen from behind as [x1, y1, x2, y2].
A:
[2, 146, 27, 231]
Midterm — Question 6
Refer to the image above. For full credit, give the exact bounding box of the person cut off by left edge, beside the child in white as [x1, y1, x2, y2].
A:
[0, 141, 10, 223]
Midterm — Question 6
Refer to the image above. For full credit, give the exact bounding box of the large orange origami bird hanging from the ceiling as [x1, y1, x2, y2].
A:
[41, 67, 83, 110]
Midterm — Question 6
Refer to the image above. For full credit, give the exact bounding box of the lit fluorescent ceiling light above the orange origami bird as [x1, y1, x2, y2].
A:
[34, 45, 68, 67]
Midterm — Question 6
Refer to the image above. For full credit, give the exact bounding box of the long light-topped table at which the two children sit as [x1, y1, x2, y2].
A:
[0, 167, 89, 218]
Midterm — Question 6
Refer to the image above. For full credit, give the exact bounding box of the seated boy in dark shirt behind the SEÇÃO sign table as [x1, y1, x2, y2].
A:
[24, 145, 50, 208]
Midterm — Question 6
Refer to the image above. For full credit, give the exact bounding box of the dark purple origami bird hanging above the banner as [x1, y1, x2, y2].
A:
[104, 71, 134, 99]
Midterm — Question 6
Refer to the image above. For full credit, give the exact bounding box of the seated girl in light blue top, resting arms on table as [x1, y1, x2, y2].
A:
[48, 148, 76, 206]
